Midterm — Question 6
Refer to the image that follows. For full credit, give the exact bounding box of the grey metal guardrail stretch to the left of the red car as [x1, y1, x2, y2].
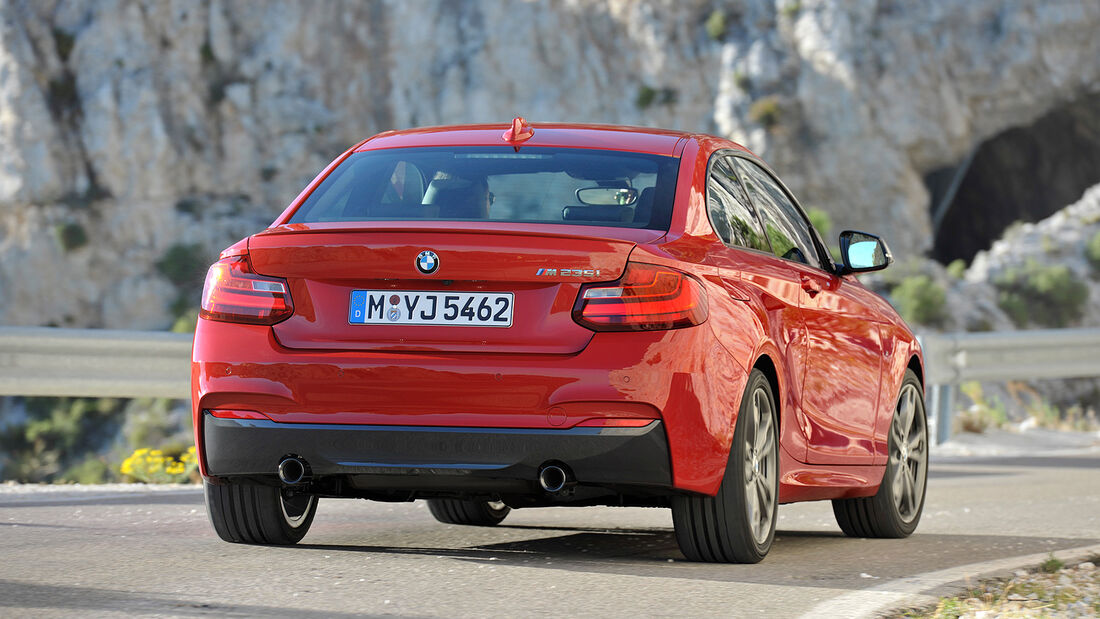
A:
[0, 327, 191, 398]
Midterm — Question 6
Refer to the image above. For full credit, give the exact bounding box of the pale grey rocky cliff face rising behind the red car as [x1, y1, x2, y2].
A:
[0, 0, 1100, 328]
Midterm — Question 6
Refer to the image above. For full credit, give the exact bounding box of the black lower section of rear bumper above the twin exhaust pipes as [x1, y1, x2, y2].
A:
[202, 414, 672, 493]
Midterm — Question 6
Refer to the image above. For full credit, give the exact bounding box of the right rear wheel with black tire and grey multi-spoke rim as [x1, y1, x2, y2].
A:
[672, 369, 779, 563]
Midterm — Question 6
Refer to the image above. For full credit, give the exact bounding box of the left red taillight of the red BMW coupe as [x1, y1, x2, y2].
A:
[199, 256, 294, 324]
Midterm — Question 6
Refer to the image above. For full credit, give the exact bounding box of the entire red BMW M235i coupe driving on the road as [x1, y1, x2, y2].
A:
[191, 119, 928, 563]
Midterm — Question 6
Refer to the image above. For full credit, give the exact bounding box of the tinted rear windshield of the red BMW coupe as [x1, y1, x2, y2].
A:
[289, 146, 680, 230]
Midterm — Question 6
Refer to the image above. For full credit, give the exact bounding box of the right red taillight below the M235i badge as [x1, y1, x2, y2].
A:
[573, 263, 707, 331]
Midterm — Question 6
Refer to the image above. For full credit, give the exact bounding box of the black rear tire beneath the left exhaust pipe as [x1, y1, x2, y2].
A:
[202, 482, 317, 545]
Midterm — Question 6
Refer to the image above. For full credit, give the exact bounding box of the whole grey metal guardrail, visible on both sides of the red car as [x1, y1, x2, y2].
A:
[0, 327, 1100, 442]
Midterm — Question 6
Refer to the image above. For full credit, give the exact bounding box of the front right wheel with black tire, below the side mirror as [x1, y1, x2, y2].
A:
[833, 371, 928, 538]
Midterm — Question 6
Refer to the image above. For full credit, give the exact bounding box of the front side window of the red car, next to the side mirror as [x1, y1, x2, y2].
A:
[737, 158, 822, 268]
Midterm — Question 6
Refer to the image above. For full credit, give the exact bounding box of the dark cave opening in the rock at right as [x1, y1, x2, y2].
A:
[924, 95, 1100, 264]
